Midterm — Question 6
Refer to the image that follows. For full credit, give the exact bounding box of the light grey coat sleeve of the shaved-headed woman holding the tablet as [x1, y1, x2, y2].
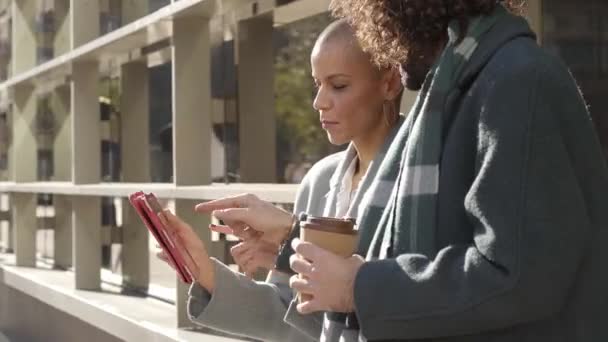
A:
[188, 156, 336, 342]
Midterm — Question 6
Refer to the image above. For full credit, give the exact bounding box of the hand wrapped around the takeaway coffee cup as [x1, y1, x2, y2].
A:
[289, 239, 365, 314]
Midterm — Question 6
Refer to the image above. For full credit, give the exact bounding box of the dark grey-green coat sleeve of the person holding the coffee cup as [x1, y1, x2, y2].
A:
[354, 63, 599, 340]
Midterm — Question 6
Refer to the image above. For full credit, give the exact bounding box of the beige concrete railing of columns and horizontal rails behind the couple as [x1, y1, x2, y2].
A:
[0, 0, 329, 334]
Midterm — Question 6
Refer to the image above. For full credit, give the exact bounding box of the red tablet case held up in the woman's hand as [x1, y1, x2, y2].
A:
[129, 191, 193, 284]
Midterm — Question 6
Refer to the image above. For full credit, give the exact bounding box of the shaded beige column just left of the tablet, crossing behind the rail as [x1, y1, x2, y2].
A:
[120, 61, 150, 290]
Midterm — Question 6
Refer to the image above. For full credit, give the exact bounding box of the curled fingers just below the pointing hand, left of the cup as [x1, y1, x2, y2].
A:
[230, 239, 279, 278]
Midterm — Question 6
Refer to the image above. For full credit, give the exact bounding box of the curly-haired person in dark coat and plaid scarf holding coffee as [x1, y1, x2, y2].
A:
[276, 0, 608, 342]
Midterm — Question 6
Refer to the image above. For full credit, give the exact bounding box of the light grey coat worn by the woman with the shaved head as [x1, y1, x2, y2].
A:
[188, 120, 403, 342]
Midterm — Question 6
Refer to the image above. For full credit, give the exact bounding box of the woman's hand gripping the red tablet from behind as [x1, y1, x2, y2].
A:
[157, 209, 215, 292]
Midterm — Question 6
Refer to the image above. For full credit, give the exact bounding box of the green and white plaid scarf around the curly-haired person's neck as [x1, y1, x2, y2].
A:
[357, 6, 508, 259]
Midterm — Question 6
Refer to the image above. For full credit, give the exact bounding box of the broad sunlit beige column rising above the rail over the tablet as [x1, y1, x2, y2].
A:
[172, 17, 213, 185]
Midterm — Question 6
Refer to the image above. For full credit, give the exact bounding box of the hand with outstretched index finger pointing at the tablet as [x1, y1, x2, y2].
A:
[195, 194, 294, 244]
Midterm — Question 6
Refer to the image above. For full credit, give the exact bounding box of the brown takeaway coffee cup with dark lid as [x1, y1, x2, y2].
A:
[299, 216, 358, 302]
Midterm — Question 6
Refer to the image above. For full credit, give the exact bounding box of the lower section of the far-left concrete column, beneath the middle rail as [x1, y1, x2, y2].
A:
[11, 193, 37, 267]
